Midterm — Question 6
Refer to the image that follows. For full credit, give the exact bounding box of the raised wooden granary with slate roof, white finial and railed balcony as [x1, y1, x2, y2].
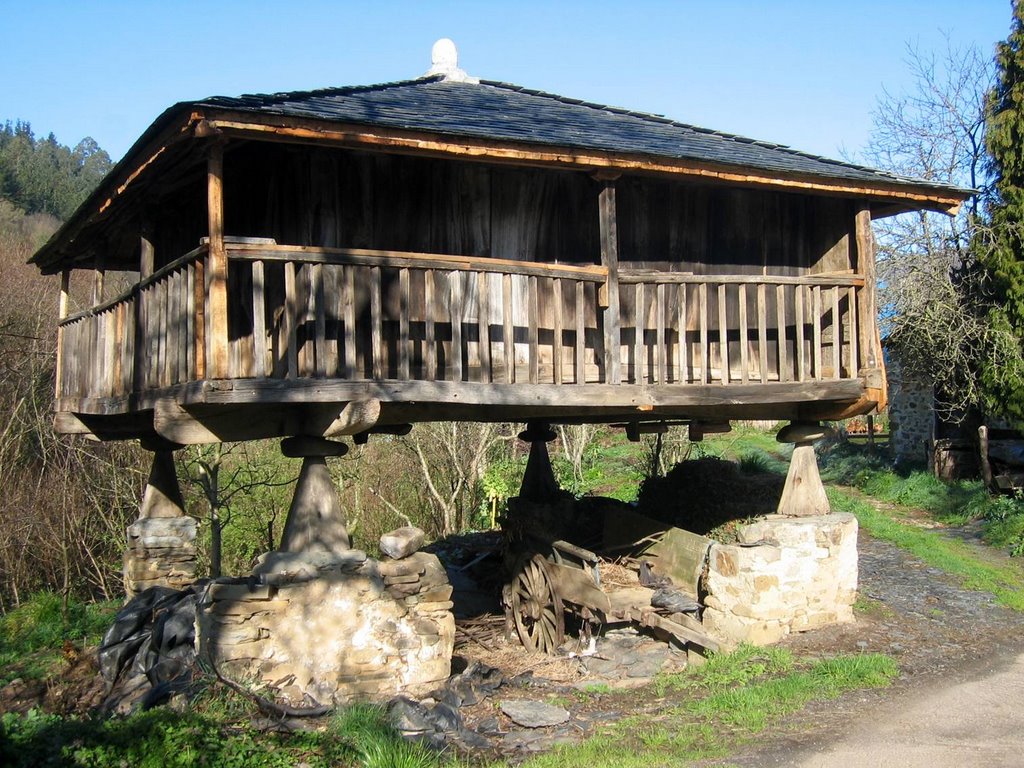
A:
[33, 43, 969, 671]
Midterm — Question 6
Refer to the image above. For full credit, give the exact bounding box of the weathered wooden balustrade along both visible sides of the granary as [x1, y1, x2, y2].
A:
[57, 242, 864, 409]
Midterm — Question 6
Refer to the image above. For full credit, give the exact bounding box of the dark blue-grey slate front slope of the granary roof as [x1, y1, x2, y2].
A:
[197, 76, 969, 194]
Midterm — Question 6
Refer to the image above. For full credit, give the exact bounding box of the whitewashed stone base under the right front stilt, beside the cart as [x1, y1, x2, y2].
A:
[702, 514, 857, 645]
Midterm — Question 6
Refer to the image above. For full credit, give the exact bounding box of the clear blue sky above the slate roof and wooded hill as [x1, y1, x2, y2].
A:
[0, 0, 1010, 159]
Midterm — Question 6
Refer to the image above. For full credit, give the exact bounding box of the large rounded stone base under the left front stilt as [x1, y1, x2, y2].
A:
[198, 550, 455, 706]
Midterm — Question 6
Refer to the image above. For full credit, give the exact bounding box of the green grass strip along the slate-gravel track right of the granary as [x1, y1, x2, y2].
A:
[828, 489, 1024, 611]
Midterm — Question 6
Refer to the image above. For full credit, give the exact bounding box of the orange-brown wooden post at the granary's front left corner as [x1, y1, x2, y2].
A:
[207, 142, 228, 379]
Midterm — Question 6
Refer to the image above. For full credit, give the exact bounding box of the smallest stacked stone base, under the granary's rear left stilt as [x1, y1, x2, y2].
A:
[124, 516, 198, 599]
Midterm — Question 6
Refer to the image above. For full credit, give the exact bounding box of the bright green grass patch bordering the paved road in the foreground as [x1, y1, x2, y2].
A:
[523, 645, 899, 768]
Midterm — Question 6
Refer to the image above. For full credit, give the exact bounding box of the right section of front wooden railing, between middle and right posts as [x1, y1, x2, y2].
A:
[618, 270, 864, 391]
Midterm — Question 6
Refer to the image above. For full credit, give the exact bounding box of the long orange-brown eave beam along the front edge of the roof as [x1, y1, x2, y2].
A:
[197, 111, 967, 214]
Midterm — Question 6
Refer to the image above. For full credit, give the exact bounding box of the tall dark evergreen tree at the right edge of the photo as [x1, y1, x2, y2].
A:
[976, 0, 1024, 426]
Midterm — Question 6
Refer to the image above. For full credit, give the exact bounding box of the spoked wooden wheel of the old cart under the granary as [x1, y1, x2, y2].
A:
[509, 555, 565, 653]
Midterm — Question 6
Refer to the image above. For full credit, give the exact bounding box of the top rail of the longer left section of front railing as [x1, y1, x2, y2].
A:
[226, 243, 608, 283]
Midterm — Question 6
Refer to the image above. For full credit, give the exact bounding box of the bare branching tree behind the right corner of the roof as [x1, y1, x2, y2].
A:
[862, 38, 1016, 418]
